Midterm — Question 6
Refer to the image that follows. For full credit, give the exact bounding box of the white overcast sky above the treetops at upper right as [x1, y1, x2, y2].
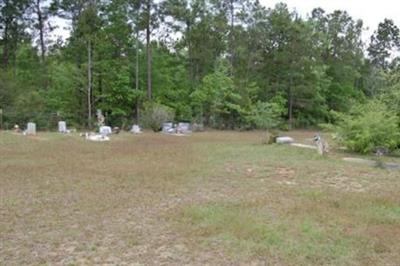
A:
[260, 0, 400, 41]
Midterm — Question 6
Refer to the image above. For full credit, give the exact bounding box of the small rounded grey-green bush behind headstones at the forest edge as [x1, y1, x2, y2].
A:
[142, 103, 175, 132]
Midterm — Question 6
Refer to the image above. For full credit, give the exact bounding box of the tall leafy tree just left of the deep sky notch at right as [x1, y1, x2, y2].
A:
[313, 10, 364, 111]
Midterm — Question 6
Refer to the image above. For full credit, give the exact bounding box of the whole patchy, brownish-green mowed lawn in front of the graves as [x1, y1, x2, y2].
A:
[0, 132, 400, 265]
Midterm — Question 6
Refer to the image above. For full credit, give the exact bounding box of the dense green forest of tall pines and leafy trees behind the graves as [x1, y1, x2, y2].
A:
[0, 0, 400, 139]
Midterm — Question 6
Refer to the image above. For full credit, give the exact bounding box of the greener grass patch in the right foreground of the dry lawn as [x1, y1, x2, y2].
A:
[180, 203, 352, 265]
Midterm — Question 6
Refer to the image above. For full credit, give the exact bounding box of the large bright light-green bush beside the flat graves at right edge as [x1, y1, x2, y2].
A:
[335, 100, 400, 154]
